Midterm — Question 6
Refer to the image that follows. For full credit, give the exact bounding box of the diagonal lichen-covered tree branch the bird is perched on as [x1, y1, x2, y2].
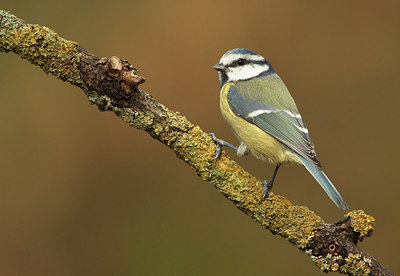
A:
[0, 10, 391, 275]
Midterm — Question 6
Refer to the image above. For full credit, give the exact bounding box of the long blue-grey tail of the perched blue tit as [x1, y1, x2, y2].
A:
[299, 156, 349, 211]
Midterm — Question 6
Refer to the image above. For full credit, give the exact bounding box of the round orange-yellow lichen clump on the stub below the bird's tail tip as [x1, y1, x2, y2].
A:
[345, 210, 375, 241]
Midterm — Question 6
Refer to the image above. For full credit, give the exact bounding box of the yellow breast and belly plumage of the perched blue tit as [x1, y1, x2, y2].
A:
[220, 83, 301, 164]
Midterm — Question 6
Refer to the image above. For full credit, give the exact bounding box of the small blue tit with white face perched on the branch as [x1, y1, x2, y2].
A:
[211, 48, 348, 210]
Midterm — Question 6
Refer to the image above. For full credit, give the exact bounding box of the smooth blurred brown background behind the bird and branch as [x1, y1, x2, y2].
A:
[0, 0, 400, 275]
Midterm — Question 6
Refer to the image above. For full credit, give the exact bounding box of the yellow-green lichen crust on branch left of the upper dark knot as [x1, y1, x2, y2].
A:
[0, 11, 83, 87]
